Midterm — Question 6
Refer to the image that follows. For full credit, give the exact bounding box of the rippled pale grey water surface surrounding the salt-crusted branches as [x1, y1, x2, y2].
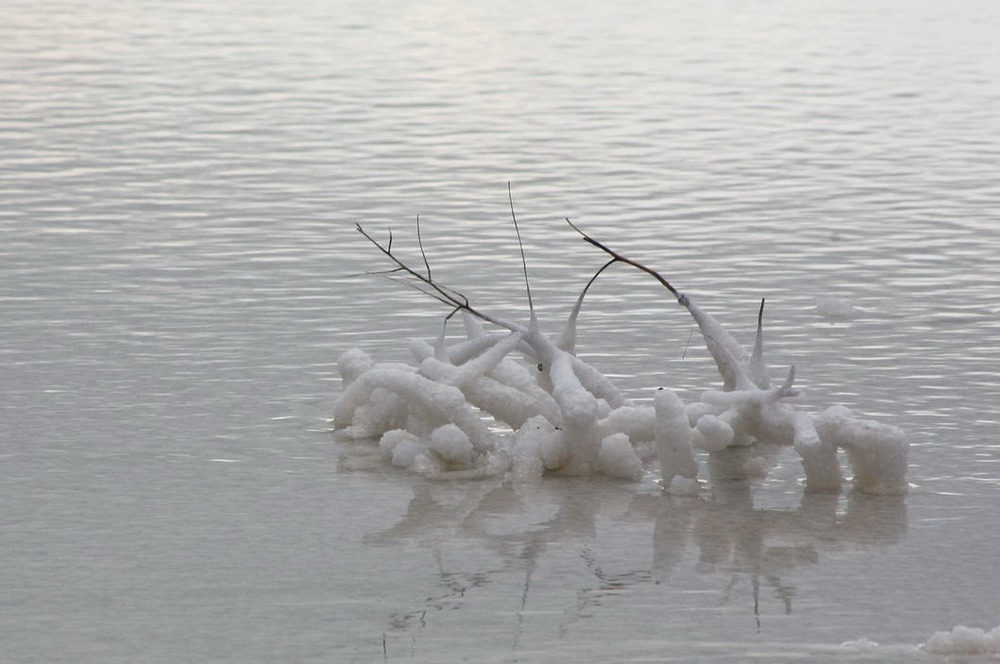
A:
[0, 0, 1000, 662]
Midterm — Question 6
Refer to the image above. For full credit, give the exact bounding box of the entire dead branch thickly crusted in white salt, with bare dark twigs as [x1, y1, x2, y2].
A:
[334, 222, 908, 494]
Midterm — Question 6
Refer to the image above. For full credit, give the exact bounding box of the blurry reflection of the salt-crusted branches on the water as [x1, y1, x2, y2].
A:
[365, 448, 907, 651]
